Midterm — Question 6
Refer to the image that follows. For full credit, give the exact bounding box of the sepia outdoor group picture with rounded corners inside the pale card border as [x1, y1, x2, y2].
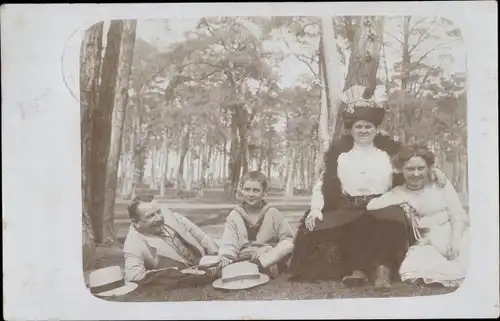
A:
[79, 15, 470, 302]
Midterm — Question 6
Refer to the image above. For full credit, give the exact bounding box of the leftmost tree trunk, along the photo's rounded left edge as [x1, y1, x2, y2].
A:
[80, 22, 104, 262]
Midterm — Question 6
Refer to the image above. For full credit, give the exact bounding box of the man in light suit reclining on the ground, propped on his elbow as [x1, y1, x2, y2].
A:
[123, 196, 218, 287]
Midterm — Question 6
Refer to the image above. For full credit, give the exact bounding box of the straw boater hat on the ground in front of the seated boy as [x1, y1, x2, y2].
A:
[212, 261, 269, 290]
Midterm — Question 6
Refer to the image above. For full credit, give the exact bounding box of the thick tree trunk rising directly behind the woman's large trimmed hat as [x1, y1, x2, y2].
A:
[334, 16, 384, 140]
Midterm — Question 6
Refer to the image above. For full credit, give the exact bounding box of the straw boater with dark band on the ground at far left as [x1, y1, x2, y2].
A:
[89, 266, 137, 297]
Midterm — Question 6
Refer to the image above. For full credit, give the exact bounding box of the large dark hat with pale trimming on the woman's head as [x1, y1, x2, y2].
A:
[342, 85, 385, 126]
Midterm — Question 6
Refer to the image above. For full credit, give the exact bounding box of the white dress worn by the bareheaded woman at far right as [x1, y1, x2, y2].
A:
[368, 182, 470, 287]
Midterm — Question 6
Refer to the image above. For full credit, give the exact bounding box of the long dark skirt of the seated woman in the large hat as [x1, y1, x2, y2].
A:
[289, 206, 412, 281]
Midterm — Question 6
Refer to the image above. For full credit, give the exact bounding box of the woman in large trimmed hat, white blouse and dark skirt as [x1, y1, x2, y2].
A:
[289, 87, 442, 290]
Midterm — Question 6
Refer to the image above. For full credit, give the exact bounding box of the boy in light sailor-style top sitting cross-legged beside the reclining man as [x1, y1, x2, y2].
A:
[218, 171, 294, 276]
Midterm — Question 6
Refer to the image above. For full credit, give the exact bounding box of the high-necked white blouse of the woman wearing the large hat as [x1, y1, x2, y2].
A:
[337, 144, 392, 196]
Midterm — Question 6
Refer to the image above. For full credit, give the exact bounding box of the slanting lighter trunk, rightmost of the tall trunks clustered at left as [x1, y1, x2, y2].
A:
[103, 20, 137, 243]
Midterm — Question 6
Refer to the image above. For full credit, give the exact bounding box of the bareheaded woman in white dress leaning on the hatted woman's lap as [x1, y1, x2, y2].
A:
[367, 145, 469, 287]
